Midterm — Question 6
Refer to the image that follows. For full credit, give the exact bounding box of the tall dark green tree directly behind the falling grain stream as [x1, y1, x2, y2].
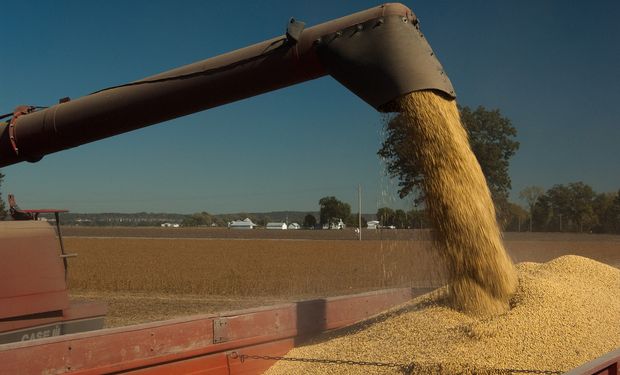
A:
[378, 106, 519, 223]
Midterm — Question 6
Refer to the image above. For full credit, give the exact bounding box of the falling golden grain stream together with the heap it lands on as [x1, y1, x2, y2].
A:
[268, 91, 620, 374]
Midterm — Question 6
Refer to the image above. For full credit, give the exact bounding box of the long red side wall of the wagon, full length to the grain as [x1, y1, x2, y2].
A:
[0, 288, 424, 374]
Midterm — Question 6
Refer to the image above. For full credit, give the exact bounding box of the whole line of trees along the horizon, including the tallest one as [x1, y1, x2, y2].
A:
[0, 106, 620, 233]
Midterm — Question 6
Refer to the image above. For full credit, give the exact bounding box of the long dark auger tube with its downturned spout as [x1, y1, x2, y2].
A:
[0, 3, 455, 167]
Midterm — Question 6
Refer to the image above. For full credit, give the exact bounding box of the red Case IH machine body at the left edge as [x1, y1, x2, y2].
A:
[0, 194, 106, 344]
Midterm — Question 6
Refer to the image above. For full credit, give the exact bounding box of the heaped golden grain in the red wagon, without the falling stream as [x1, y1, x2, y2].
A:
[267, 256, 620, 375]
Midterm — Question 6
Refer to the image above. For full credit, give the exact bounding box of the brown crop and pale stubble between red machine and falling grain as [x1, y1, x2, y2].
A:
[65, 236, 441, 327]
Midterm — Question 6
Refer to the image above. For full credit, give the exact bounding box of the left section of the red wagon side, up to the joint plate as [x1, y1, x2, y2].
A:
[0, 319, 213, 374]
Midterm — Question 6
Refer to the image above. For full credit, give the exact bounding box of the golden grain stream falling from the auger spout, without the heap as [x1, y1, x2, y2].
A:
[399, 91, 516, 315]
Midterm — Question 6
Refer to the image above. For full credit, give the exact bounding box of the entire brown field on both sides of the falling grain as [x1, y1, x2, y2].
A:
[63, 228, 620, 326]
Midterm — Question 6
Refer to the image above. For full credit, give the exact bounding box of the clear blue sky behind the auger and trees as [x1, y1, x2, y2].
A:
[0, 0, 620, 213]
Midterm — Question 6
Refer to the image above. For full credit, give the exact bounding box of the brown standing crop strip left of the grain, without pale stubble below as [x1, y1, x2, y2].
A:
[66, 238, 440, 296]
